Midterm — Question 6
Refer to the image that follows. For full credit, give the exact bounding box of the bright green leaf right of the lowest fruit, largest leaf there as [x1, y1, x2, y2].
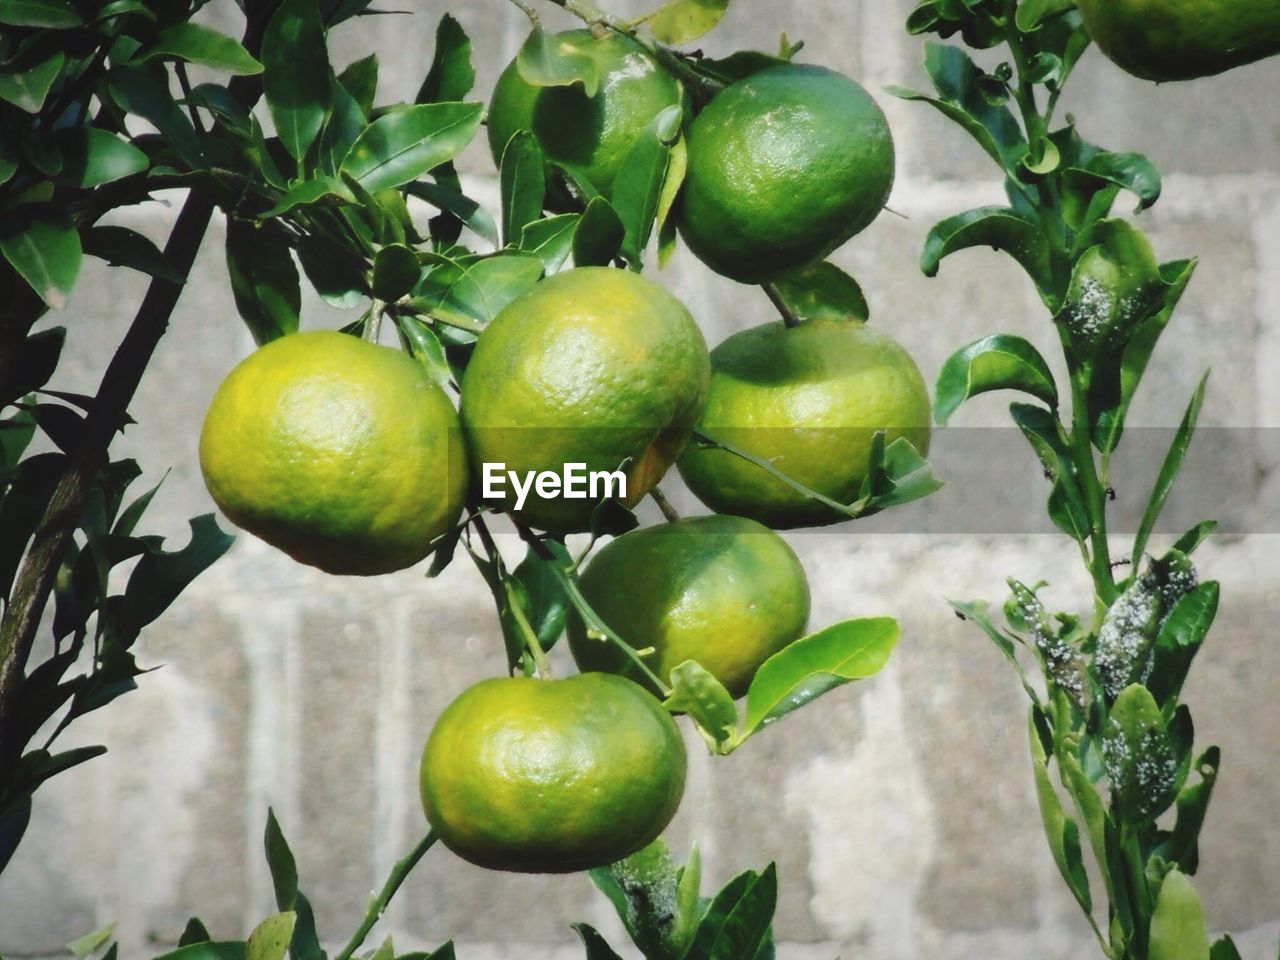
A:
[737, 617, 899, 742]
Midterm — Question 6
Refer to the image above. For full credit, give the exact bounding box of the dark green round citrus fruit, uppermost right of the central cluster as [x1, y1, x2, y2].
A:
[680, 64, 893, 283]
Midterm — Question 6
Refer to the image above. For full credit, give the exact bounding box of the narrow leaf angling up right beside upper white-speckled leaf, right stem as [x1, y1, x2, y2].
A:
[1088, 253, 1197, 453]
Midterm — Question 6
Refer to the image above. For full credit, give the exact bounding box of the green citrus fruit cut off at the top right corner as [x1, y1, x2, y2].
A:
[1076, 0, 1280, 81]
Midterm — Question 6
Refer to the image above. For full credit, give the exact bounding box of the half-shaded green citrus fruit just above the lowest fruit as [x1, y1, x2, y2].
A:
[568, 516, 809, 696]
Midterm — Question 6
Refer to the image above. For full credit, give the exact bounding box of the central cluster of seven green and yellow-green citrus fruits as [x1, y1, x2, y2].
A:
[200, 24, 929, 872]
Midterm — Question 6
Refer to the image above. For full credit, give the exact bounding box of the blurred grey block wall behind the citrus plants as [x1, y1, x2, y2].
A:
[0, 0, 1280, 960]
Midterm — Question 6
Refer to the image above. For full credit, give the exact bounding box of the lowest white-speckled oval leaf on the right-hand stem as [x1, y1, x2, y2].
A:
[1102, 684, 1175, 823]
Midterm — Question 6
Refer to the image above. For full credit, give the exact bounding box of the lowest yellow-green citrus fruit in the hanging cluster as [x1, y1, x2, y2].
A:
[420, 673, 686, 873]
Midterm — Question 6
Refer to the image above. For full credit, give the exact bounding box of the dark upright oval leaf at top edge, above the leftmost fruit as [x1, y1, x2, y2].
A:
[262, 0, 333, 161]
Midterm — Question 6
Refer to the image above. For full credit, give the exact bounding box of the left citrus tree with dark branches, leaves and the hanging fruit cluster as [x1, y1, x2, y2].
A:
[0, 0, 938, 960]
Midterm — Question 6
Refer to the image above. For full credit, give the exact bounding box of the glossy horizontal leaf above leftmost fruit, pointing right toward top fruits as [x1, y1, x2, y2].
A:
[342, 102, 484, 193]
